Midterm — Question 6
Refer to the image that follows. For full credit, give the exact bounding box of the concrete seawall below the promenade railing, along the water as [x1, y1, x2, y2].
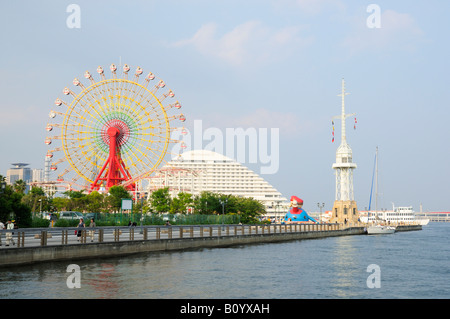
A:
[0, 227, 365, 267]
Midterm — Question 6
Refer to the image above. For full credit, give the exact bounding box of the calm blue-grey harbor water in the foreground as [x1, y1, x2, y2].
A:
[0, 223, 450, 299]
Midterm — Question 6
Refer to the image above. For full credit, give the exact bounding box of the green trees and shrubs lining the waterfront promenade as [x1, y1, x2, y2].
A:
[0, 176, 265, 228]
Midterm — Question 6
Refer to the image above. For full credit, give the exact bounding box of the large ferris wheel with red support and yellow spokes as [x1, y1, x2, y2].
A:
[45, 64, 186, 191]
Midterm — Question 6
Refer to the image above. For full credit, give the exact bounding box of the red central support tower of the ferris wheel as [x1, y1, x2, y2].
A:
[91, 126, 136, 191]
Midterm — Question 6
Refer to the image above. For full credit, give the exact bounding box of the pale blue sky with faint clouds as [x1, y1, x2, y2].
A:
[0, 0, 450, 211]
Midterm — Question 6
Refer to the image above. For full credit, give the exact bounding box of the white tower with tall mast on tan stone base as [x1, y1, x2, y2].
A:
[330, 79, 359, 224]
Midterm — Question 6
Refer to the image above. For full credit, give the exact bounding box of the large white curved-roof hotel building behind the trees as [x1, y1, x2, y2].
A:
[149, 150, 289, 217]
